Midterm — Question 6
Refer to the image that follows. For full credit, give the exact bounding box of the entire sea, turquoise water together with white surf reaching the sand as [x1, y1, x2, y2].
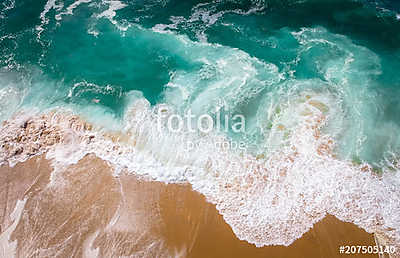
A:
[0, 0, 400, 246]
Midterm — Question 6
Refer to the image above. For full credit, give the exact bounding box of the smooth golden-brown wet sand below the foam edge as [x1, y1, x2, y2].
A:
[0, 156, 377, 258]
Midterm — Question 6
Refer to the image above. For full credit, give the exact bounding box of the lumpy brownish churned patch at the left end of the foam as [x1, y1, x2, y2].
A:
[0, 113, 95, 165]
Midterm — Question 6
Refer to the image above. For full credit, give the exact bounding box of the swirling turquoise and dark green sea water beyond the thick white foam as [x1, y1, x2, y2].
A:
[0, 0, 400, 167]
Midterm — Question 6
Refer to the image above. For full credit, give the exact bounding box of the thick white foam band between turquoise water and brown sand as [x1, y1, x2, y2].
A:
[3, 92, 400, 246]
